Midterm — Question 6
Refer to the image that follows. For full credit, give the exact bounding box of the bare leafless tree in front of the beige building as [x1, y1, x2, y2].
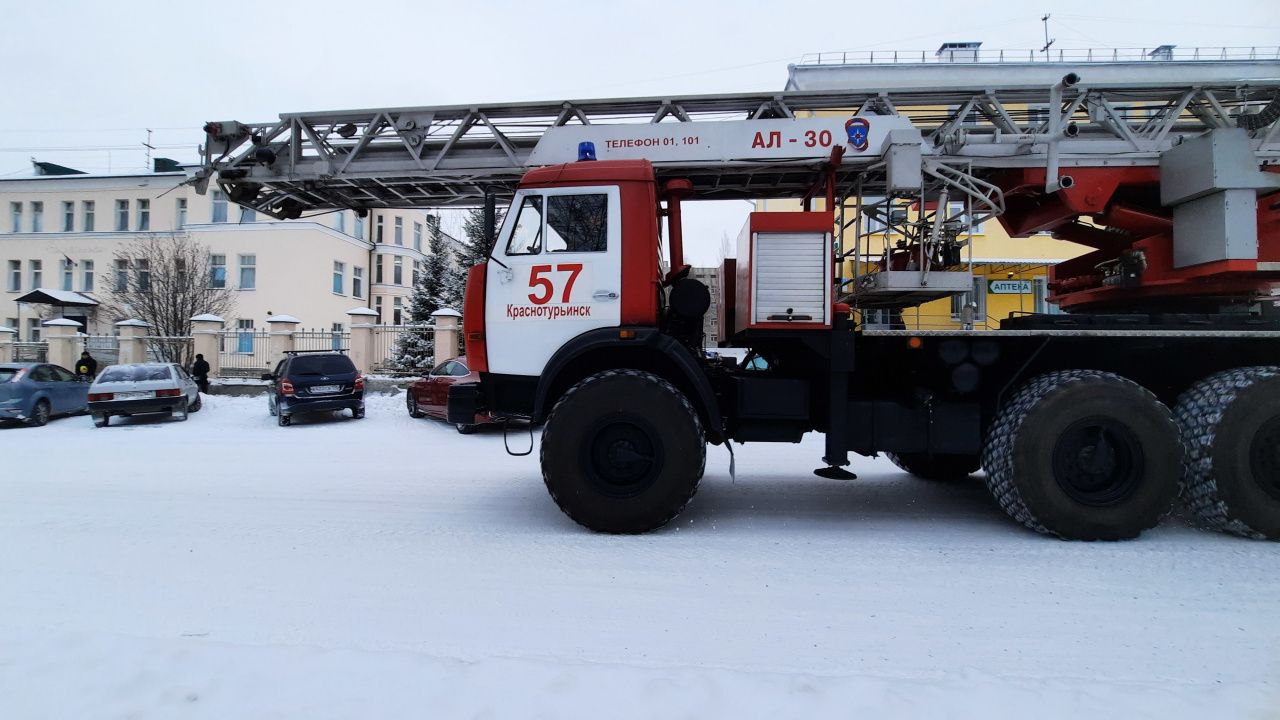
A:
[102, 233, 236, 366]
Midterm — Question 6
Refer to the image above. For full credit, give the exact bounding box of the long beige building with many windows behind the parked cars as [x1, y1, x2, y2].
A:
[0, 164, 445, 341]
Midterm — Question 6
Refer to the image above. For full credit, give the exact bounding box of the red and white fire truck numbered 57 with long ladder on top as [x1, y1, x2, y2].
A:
[193, 53, 1280, 539]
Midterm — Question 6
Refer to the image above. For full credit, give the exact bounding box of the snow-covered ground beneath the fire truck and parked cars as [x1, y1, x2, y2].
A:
[0, 396, 1280, 720]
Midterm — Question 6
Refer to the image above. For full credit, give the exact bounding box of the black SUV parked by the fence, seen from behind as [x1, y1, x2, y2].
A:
[262, 351, 365, 427]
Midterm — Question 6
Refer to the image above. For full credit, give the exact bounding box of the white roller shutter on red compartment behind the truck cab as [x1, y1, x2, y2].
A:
[751, 232, 831, 323]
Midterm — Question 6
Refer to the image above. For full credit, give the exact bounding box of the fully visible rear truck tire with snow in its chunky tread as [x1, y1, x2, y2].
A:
[982, 370, 1183, 541]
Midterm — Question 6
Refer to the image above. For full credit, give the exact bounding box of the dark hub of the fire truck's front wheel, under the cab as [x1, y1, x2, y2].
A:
[582, 418, 662, 497]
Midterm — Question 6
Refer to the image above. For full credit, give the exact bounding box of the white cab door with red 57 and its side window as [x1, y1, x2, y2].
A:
[485, 186, 622, 375]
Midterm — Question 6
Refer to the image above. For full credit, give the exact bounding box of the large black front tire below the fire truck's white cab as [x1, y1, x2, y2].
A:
[540, 370, 707, 533]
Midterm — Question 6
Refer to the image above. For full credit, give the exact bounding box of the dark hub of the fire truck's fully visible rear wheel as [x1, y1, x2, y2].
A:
[1053, 416, 1144, 507]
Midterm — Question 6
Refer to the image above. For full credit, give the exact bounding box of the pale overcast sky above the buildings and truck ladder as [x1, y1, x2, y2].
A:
[0, 0, 1280, 264]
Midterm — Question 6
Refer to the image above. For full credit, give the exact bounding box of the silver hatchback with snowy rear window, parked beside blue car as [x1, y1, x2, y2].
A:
[88, 363, 200, 428]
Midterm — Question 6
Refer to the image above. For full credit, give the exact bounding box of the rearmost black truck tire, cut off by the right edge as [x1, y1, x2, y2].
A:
[1174, 366, 1280, 539]
